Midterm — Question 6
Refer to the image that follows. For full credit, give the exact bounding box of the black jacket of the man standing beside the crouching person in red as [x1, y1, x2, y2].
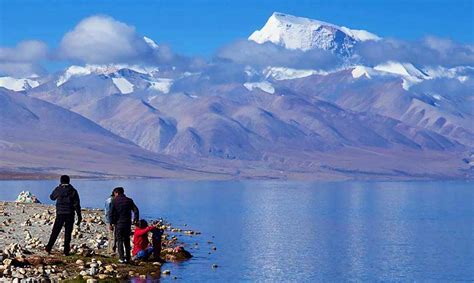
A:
[110, 195, 139, 228]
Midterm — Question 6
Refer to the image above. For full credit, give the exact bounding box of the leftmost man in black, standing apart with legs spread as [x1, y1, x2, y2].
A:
[45, 175, 82, 256]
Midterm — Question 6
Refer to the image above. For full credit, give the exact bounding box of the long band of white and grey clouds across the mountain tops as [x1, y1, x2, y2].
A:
[0, 15, 474, 77]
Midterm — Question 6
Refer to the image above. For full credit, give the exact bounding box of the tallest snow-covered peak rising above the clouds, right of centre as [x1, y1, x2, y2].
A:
[248, 13, 380, 56]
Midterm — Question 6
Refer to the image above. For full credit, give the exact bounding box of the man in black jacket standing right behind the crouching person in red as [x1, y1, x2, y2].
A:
[110, 187, 139, 263]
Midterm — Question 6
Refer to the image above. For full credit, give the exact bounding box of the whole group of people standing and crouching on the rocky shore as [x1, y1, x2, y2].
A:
[45, 175, 162, 263]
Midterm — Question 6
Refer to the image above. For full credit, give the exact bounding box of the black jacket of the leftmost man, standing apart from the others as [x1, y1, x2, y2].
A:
[49, 184, 82, 219]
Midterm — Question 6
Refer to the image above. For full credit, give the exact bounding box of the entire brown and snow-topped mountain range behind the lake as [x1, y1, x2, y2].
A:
[0, 13, 474, 180]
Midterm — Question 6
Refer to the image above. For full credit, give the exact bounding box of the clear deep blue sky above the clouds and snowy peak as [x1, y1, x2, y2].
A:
[0, 0, 474, 56]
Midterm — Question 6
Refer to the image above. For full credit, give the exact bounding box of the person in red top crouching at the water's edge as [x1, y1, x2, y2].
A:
[132, 219, 162, 260]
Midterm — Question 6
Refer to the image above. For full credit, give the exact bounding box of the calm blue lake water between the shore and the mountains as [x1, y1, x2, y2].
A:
[0, 180, 474, 282]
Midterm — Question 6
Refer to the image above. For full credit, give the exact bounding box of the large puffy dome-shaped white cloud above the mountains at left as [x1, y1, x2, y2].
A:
[59, 16, 153, 64]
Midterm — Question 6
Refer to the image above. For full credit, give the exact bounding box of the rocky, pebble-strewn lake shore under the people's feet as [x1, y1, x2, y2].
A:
[0, 202, 200, 282]
